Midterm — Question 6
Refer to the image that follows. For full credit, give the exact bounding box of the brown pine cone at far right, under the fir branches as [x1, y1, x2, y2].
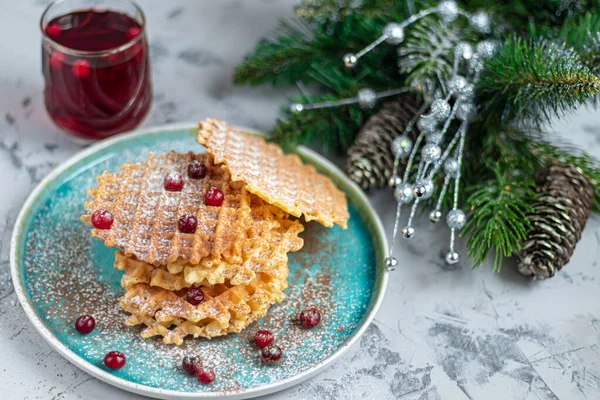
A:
[518, 165, 594, 279]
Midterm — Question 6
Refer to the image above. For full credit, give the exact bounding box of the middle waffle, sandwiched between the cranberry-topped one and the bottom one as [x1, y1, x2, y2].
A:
[114, 206, 304, 291]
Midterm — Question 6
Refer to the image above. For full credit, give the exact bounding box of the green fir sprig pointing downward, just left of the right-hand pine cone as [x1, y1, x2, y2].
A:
[462, 165, 533, 271]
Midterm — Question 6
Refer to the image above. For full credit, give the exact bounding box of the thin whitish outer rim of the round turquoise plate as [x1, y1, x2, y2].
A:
[10, 123, 389, 399]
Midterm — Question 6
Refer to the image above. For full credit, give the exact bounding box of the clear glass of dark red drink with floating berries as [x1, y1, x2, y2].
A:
[40, 0, 152, 142]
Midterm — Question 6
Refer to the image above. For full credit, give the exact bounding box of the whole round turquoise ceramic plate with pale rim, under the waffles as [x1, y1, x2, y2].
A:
[11, 124, 387, 398]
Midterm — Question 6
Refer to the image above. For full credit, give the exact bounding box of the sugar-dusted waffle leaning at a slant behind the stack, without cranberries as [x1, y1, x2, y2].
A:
[197, 119, 349, 228]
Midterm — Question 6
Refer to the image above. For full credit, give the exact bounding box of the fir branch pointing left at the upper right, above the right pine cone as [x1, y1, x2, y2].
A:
[478, 37, 600, 125]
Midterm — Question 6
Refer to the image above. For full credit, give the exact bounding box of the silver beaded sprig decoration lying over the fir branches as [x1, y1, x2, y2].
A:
[291, 0, 497, 271]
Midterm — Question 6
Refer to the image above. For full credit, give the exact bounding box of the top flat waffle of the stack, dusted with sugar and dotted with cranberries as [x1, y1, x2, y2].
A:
[81, 152, 300, 265]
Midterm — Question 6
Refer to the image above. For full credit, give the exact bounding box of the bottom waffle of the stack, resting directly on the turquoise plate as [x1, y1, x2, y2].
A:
[119, 256, 288, 345]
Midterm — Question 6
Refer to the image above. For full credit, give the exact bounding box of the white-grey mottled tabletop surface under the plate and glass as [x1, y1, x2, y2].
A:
[0, 0, 600, 400]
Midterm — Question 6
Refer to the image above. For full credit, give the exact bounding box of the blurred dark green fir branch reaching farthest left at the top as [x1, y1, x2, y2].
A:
[234, 6, 408, 85]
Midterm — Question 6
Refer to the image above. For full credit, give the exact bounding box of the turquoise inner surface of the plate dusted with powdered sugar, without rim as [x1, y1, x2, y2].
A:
[16, 135, 375, 392]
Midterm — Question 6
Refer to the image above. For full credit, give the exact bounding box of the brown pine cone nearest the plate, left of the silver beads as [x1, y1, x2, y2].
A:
[346, 96, 419, 190]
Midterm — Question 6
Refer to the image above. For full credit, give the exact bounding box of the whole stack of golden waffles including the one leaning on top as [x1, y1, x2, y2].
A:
[82, 120, 349, 345]
